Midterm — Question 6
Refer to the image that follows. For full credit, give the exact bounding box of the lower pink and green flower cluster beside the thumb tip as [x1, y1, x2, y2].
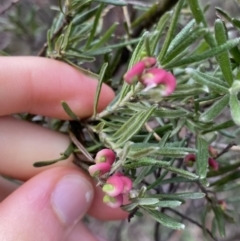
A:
[88, 149, 132, 208]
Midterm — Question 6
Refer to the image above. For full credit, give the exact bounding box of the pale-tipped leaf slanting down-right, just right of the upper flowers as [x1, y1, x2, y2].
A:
[186, 68, 229, 93]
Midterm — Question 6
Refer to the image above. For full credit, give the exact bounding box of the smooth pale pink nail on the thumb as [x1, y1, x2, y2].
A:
[51, 174, 93, 226]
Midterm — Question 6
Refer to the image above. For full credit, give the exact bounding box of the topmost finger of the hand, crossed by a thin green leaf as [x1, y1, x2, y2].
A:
[0, 57, 114, 119]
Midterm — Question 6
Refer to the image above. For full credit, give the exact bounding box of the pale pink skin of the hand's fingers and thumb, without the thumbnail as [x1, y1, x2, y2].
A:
[0, 57, 127, 241]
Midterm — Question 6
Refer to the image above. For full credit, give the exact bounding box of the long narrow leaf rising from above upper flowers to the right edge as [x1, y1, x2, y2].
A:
[162, 38, 240, 69]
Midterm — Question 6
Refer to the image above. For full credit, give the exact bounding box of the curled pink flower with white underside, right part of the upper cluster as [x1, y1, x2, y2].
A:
[140, 68, 176, 96]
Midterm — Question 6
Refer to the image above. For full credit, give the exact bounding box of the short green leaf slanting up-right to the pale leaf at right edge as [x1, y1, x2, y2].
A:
[199, 94, 229, 122]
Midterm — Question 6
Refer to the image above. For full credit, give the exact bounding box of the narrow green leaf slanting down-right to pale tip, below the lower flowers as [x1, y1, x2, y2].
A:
[146, 209, 185, 230]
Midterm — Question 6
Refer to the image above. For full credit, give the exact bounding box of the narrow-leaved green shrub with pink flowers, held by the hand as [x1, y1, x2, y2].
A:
[4, 0, 240, 240]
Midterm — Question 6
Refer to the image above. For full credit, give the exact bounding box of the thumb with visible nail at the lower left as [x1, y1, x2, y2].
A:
[0, 167, 93, 241]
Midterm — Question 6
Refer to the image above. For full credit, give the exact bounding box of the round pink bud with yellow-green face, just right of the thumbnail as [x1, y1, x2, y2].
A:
[102, 176, 124, 197]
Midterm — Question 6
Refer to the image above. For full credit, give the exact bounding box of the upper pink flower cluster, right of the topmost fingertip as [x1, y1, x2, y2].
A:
[123, 57, 176, 96]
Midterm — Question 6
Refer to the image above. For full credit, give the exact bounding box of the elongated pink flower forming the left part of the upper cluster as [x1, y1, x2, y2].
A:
[123, 57, 157, 85]
